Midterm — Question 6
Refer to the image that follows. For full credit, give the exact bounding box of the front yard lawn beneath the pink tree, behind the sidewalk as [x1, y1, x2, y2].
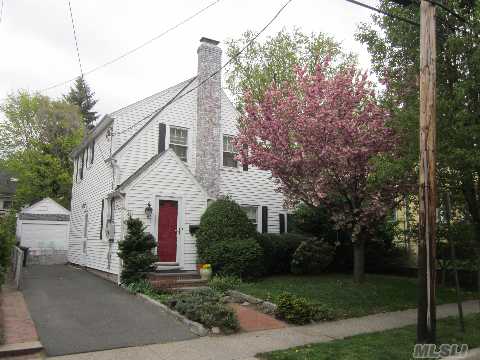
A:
[238, 274, 475, 319]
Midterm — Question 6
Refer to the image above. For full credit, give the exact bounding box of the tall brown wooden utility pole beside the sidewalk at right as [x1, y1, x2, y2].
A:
[417, 0, 437, 344]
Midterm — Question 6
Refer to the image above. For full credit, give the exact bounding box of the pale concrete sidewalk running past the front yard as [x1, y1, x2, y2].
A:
[50, 301, 479, 360]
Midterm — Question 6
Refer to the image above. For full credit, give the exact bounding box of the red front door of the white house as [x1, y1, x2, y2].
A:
[157, 200, 178, 262]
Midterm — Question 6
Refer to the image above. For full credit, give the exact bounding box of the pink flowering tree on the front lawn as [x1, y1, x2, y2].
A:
[236, 60, 399, 282]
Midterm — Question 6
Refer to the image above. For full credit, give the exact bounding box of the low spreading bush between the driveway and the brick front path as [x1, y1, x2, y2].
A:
[165, 289, 239, 333]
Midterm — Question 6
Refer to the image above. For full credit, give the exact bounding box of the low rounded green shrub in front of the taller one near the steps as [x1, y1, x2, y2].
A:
[202, 239, 264, 278]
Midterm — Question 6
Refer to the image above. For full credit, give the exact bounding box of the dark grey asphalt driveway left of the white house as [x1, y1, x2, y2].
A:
[23, 265, 197, 356]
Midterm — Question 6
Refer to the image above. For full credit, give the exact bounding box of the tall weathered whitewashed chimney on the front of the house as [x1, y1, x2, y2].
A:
[195, 37, 222, 198]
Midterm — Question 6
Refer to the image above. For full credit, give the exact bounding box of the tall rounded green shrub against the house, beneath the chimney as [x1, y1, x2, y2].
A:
[195, 197, 257, 262]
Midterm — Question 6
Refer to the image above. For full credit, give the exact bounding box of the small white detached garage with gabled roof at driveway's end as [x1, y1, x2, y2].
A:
[17, 198, 70, 264]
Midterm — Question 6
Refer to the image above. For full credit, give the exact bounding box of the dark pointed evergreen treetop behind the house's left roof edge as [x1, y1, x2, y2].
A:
[64, 77, 99, 128]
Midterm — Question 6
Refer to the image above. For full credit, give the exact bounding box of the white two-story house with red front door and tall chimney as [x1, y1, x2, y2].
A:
[68, 38, 288, 282]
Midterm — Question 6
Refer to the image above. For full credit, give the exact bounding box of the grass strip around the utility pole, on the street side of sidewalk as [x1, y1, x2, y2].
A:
[257, 314, 480, 360]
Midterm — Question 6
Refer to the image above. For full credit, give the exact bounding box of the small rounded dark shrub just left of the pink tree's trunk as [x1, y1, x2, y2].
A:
[291, 239, 335, 274]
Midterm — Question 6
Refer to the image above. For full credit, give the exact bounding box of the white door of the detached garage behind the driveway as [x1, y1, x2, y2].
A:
[21, 222, 68, 250]
